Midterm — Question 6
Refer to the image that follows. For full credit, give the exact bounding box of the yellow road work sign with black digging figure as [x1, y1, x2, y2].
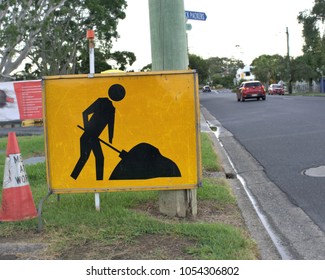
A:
[43, 71, 201, 193]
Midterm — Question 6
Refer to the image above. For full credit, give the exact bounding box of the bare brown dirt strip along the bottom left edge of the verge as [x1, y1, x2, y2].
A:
[0, 234, 195, 260]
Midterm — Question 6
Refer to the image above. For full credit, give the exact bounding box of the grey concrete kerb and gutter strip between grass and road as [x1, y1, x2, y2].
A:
[201, 107, 325, 260]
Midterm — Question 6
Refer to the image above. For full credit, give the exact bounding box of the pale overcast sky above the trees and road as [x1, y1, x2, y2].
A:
[113, 0, 314, 71]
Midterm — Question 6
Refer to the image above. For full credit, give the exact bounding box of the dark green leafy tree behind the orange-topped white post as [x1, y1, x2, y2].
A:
[30, 0, 132, 75]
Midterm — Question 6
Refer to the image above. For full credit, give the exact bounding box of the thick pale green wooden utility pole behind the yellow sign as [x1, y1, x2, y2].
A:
[148, 0, 197, 217]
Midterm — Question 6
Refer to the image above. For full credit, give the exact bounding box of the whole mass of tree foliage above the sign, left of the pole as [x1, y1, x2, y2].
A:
[0, 0, 136, 77]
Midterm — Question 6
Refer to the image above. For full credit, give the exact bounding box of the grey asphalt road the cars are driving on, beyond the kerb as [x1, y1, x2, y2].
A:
[200, 92, 325, 258]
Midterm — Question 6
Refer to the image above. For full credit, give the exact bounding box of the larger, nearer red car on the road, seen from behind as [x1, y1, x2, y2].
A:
[237, 81, 266, 102]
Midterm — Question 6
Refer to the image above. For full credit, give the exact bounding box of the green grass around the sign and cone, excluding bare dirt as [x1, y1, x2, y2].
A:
[0, 133, 258, 260]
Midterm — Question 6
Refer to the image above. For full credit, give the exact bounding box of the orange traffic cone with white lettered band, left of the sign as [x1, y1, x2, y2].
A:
[0, 132, 37, 221]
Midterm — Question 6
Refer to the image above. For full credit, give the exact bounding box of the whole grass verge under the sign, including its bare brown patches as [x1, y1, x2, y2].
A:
[0, 133, 259, 260]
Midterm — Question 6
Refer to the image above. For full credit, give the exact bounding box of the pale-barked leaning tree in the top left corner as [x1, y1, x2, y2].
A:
[0, 0, 65, 78]
